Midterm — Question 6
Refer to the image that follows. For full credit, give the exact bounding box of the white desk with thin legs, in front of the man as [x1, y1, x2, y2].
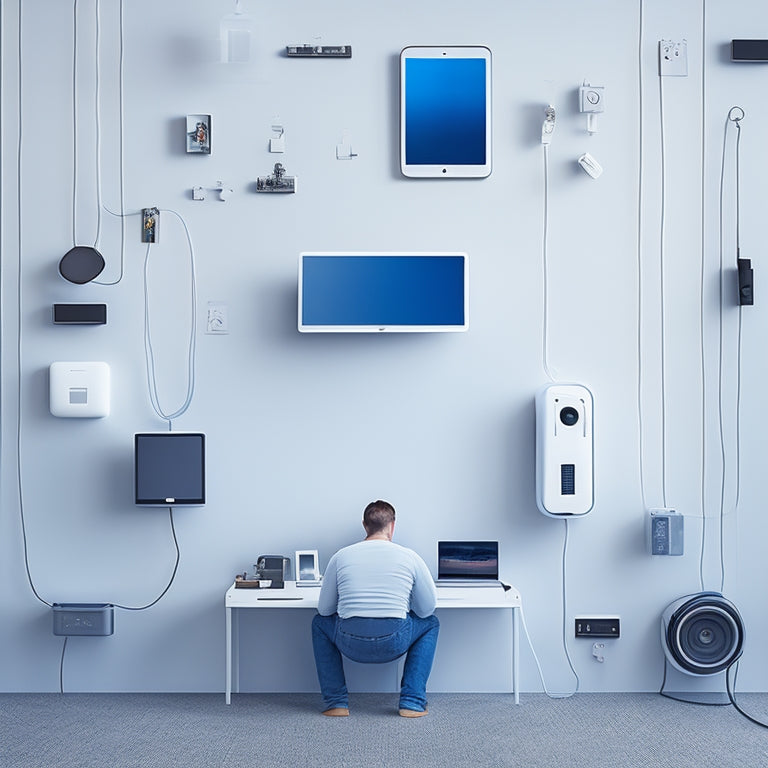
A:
[224, 581, 522, 704]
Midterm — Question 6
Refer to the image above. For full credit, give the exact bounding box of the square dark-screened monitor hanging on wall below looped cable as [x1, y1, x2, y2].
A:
[134, 432, 205, 507]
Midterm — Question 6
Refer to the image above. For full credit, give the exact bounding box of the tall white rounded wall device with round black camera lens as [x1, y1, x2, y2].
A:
[536, 384, 594, 517]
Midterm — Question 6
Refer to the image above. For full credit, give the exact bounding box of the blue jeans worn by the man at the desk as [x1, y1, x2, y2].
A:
[312, 612, 440, 712]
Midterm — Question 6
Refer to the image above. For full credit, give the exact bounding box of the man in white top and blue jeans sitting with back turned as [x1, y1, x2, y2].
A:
[312, 501, 440, 717]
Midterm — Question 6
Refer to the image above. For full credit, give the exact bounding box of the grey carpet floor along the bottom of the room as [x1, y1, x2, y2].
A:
[0, 694, 768, 768]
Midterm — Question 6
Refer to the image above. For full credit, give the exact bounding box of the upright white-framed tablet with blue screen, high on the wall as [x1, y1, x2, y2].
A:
[400, 46, 491, 178]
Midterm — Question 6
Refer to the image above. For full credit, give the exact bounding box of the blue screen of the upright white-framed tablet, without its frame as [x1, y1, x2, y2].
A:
[405, 58, 486, 165]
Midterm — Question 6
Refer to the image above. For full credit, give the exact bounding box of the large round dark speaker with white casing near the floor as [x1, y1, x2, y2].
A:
[661, 592, 744, 675]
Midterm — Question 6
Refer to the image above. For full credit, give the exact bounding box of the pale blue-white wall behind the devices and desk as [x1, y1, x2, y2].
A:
[0, 0, 768, 691]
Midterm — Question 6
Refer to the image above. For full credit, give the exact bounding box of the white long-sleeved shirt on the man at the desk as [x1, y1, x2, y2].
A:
[317, 539, 437, 619]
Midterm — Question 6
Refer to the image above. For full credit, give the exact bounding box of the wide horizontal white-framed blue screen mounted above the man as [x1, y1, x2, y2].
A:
[299, 253, 469, 333]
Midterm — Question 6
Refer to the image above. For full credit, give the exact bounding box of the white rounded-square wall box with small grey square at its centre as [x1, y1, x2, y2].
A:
[49, 363, 110, 419]
